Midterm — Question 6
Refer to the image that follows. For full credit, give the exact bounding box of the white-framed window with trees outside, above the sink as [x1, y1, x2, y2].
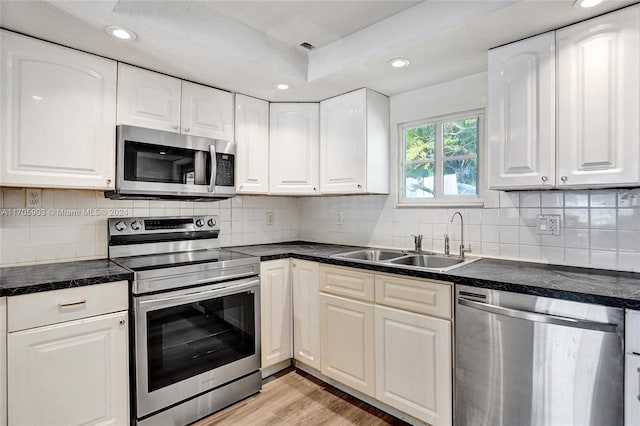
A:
[399, 111, 484, 204]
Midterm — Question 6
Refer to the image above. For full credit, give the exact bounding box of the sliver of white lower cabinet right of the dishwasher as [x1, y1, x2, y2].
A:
[624, 309, 640, 426]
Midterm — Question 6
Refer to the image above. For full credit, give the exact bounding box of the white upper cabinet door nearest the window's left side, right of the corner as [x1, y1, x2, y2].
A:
[320, 89, 367, 193]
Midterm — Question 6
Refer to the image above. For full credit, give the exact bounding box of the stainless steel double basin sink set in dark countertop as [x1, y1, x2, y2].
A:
[331, 249, 478, 272]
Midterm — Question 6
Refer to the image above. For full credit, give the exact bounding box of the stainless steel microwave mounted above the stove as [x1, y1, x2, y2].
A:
[105, 125, 236, 200]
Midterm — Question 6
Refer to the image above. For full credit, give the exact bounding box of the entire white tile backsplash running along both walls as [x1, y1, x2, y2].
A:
[0, 188, 640, 272]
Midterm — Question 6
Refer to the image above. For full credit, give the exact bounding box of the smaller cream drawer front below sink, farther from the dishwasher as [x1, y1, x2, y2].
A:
[320, 266, 374, 303]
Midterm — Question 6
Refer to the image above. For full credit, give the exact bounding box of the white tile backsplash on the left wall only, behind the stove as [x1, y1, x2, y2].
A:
[0, 188, 299, 266]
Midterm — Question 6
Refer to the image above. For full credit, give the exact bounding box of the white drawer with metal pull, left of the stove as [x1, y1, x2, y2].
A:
[7, 281, 129, 332]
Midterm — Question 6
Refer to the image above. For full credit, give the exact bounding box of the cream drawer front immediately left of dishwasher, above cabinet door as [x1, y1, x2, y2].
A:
[375, 275, 452, 319]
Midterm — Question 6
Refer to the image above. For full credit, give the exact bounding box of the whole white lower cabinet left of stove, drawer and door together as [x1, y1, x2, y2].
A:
[7, 281, 129, 426]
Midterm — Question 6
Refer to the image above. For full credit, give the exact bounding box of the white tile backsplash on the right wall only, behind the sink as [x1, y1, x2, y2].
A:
[299, 189, 640, 272]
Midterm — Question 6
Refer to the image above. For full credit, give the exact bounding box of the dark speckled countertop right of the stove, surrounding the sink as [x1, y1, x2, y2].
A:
[228, 242, 640, 309]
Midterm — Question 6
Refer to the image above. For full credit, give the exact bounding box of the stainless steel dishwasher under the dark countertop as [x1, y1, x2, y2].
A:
[454, 285, 624, 426]
